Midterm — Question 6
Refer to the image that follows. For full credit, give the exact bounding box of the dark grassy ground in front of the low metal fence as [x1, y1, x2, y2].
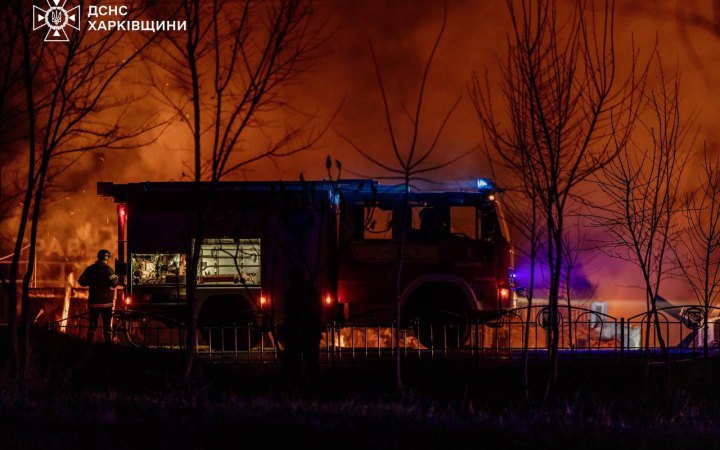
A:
[0, 331, 720, 450]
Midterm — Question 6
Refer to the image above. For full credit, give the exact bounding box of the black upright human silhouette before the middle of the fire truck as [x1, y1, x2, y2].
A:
[282, 267, 322, 385]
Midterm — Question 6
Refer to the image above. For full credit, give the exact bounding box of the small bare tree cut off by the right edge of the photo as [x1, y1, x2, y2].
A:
[673, 148, 720, 358]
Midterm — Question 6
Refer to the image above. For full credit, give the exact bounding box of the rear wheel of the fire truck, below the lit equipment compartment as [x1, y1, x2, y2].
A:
[198, 295, 262, 352]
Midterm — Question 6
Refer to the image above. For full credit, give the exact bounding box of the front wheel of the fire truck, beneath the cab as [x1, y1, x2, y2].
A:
[403, 283, 470, 349]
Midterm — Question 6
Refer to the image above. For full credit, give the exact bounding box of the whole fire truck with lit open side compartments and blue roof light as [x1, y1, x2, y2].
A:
[98, 179, 514, 345]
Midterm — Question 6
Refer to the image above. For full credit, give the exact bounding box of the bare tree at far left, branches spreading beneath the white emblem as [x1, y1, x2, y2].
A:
[6, 0, 161, 387]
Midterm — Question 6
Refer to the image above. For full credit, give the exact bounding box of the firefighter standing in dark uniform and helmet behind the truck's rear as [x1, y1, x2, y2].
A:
[78, 249, 118, 342]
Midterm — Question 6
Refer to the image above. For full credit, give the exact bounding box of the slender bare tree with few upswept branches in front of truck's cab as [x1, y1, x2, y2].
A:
[338, 5, 475, 390]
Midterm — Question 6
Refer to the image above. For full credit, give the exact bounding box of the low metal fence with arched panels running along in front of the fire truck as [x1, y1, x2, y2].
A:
[49, 306, 720, 363]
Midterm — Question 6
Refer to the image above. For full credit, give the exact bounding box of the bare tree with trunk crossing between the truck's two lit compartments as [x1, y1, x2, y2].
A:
[151, 0, 324, 377]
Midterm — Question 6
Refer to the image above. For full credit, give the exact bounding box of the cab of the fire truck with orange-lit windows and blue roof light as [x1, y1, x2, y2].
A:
[338, 180, 514, 345]
